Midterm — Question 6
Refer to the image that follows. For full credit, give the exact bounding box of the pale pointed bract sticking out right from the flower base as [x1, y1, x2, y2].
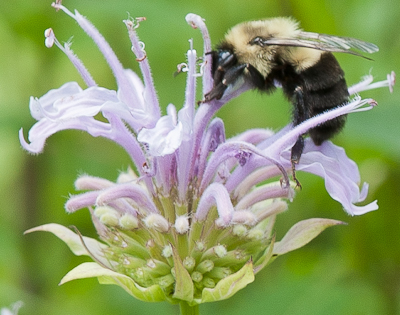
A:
[273, 218, 345, 255]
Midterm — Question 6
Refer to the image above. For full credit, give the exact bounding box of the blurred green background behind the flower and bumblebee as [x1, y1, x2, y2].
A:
[0, 0, 400, 315]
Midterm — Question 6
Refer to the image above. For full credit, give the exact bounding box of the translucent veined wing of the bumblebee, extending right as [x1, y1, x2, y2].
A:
[260, 32, 379, 58]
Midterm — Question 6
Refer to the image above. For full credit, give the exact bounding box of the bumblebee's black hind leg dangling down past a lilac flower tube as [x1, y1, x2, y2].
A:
[290, 86, 308, 188]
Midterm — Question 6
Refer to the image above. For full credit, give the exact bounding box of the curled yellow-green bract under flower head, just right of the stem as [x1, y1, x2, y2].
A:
[196, 260, 254, 304]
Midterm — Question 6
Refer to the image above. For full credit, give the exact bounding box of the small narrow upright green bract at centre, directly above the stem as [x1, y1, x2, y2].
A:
[171, 245, 194, 302]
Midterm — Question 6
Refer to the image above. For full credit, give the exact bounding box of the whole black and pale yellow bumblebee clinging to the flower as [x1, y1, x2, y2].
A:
[202, 17, 378, 186]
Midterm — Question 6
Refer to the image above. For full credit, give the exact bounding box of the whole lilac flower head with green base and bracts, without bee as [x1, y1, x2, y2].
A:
[20, 3, 394, 313]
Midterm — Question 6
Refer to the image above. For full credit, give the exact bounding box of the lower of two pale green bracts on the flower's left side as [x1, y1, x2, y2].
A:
[60, 262, 166, 302]
